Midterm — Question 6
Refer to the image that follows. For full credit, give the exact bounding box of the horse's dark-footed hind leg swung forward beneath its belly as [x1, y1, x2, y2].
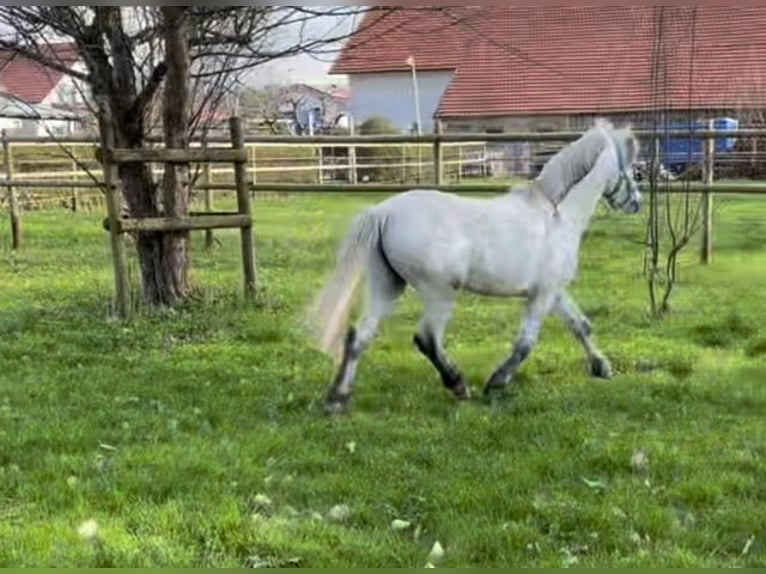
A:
[414, 288, 471, 400]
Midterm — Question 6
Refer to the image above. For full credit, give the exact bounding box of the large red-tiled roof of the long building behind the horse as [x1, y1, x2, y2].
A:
[331, 6, 766, 117]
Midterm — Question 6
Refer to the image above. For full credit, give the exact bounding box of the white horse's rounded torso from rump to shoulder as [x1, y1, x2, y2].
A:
[374, 189, 555, 295]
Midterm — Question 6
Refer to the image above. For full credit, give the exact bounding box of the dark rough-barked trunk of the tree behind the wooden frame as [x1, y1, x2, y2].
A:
[93, 6, 190, 306]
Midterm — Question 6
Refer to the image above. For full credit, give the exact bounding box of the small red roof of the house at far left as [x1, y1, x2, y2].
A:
[0, 43, 77, 104]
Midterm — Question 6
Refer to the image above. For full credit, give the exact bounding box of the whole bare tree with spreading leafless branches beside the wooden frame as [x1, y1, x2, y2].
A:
[0, 6, 396, 305]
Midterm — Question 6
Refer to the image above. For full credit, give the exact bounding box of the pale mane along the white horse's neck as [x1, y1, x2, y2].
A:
[514, 118, 615, 204]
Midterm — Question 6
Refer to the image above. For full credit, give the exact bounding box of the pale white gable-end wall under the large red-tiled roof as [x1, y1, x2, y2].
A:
[348, 71, 454, 133]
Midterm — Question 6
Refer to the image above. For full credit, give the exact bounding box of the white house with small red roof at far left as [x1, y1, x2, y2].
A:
[0, 43, 85, 136]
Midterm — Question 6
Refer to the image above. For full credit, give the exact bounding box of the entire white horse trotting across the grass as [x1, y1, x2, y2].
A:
[310, 120, 641, 411]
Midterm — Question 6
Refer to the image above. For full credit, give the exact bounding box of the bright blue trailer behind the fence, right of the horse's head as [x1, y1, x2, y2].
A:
[660, 118, 739, 175]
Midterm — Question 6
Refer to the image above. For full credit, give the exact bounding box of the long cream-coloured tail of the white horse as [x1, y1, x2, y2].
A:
[309, 209, 381, 360]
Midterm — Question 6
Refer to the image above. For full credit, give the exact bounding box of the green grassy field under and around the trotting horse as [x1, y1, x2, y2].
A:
[0, 194, 766, 567]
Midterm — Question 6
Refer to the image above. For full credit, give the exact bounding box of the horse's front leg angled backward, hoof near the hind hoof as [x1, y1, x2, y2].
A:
[484, 291, 556, 396]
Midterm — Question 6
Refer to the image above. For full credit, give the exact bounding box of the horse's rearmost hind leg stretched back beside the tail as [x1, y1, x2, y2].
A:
[325, 258, 406, 413]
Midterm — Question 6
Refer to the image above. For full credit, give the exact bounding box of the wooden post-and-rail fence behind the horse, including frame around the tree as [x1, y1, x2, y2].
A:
[0, 124, 766, 310]
